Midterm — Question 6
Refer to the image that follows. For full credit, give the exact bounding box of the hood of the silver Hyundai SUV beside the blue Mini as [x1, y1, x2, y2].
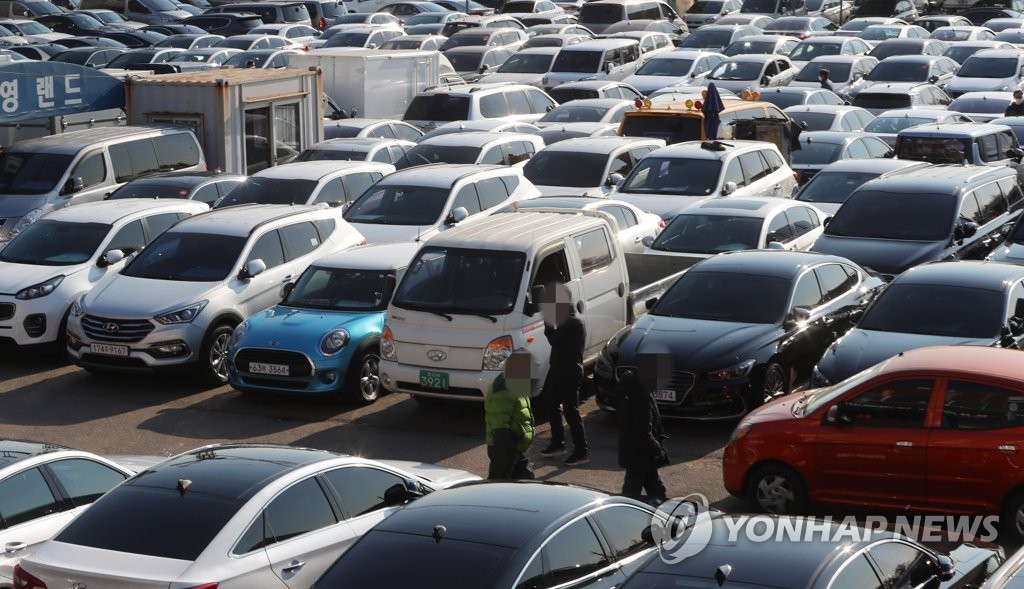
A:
[84, 275, 220, 319]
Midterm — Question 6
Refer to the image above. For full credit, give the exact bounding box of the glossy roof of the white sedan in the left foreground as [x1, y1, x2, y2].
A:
[122, 444, 343, 500]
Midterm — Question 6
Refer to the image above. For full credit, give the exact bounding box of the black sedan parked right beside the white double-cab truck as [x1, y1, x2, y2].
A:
[594, 250, 884, 420]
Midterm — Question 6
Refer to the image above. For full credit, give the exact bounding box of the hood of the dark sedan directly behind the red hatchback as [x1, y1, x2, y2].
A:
[818, 329, 993, 382]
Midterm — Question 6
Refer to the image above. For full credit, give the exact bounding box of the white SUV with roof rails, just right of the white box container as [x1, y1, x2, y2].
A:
[402, 84, 558, 131]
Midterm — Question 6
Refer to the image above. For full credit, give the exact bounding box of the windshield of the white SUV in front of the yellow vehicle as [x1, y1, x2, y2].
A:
[620, 157, 722, 197]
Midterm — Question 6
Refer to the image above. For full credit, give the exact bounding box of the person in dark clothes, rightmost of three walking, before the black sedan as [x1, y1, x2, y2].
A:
[615, 353, 672, 503]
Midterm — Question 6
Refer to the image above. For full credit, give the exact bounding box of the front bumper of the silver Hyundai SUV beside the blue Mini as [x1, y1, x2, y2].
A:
[68, 318, 206, 374]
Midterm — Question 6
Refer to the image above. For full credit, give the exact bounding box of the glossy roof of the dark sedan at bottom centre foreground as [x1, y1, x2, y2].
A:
[376, 483, 629, 548]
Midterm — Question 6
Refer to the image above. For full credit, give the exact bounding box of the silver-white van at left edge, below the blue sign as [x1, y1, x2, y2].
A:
[0, 126, 206, 248]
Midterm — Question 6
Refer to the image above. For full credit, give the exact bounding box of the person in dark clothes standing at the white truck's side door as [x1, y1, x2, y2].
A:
[541, 284, 590, 466]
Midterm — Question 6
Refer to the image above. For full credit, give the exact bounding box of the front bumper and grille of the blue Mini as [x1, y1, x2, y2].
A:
[227, 346, 354, 394]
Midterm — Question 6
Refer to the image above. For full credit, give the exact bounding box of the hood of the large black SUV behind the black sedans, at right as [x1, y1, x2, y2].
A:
[814, 236, 945, 276]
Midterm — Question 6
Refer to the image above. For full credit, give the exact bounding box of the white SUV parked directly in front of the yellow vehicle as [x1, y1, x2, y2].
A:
[609, 140, 797, 220]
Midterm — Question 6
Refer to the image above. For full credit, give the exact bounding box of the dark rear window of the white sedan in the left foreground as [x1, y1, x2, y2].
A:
[55, 485, 242, 560]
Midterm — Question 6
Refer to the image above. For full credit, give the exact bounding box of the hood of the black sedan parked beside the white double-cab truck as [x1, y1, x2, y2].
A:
[628, 314, 779, 372]
